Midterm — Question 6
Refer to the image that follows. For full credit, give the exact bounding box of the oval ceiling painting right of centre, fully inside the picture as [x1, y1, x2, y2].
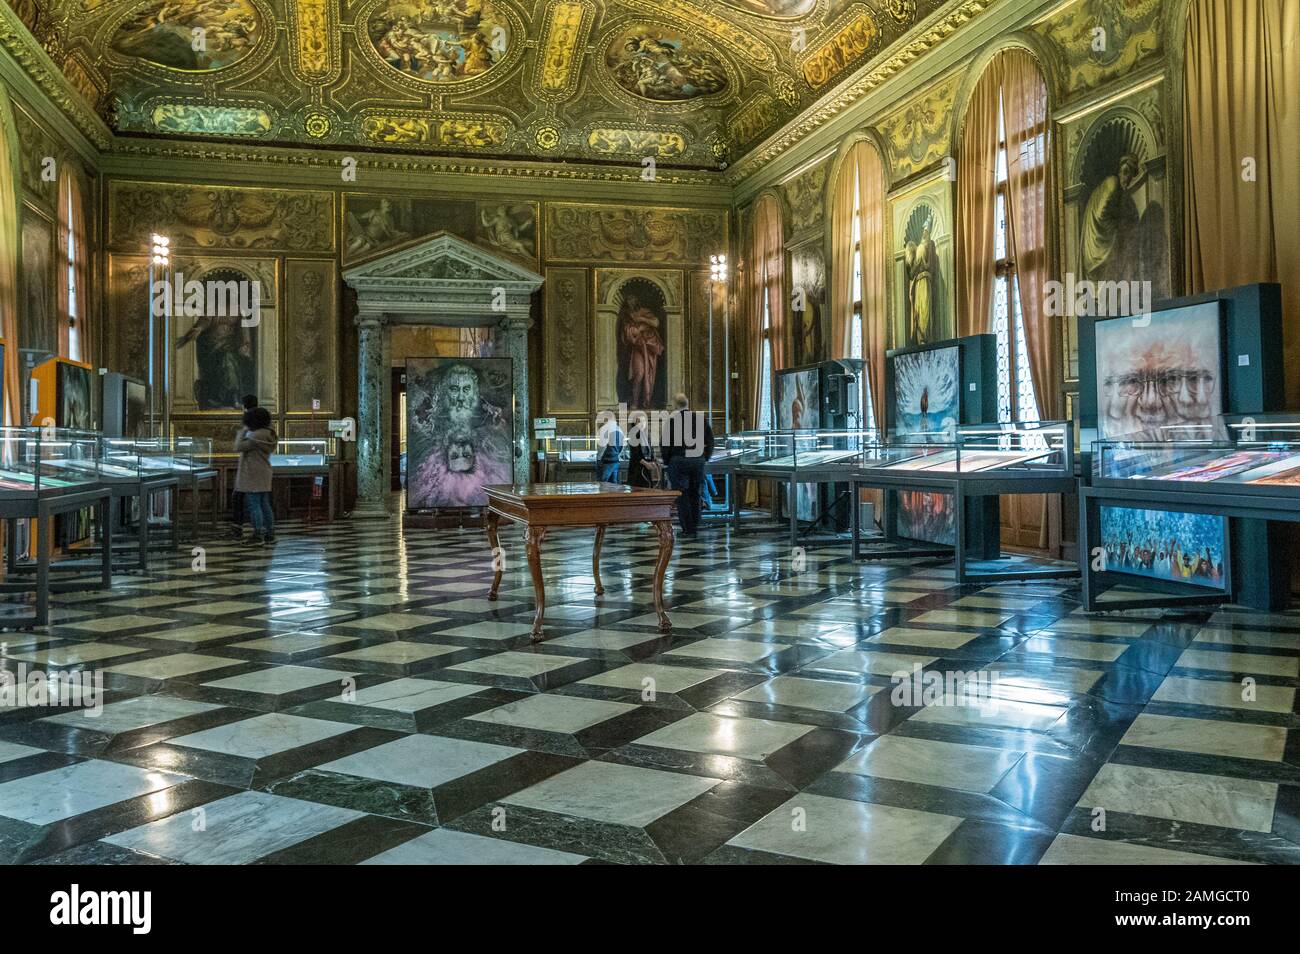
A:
[605, 23, 728, 103]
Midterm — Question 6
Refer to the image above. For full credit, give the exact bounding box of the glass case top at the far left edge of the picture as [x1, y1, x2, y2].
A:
[0, 428, 103, 496]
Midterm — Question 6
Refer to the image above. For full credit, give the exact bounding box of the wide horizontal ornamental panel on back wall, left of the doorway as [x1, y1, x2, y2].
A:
[108, 181, 334, 252]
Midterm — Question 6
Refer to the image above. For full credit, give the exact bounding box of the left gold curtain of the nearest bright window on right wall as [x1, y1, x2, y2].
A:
[957, 55, 1002, 337]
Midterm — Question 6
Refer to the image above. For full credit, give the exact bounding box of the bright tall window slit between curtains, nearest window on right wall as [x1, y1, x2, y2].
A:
[993, 95, 1039, 421]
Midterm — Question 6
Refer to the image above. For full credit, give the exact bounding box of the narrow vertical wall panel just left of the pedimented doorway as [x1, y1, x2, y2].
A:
[285, 259, 338, 413]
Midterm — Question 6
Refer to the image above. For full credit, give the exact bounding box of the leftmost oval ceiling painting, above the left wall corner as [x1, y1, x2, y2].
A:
[111, 0, 265, 71]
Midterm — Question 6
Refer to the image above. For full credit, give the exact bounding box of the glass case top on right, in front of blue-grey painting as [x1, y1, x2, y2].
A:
[862, 421, 1074, 480]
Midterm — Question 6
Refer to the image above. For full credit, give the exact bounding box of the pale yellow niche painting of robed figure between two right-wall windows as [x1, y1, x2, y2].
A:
[889, 179, 957, 348]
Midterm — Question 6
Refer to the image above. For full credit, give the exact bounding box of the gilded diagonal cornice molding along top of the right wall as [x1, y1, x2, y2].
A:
[727, 0, 997, 185]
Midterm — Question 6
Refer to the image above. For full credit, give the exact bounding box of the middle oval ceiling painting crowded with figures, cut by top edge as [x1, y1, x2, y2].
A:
[367, 0, 511, 83]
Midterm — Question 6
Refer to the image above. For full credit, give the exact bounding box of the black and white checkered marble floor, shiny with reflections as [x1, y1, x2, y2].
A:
[0, 521, 1300, 864]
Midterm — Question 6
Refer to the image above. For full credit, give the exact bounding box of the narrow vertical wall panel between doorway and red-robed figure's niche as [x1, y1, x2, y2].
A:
[542, 268, 592, 415]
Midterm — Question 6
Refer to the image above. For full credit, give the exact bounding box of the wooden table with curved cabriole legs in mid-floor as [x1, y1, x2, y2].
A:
[484, 482, 679, 642]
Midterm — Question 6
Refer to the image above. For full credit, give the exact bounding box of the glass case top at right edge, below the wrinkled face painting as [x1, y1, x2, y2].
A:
[1093, 415, 1300, 496]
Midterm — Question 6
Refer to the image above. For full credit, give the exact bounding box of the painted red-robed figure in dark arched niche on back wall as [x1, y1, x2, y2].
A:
[615, 278, 668, 408]
